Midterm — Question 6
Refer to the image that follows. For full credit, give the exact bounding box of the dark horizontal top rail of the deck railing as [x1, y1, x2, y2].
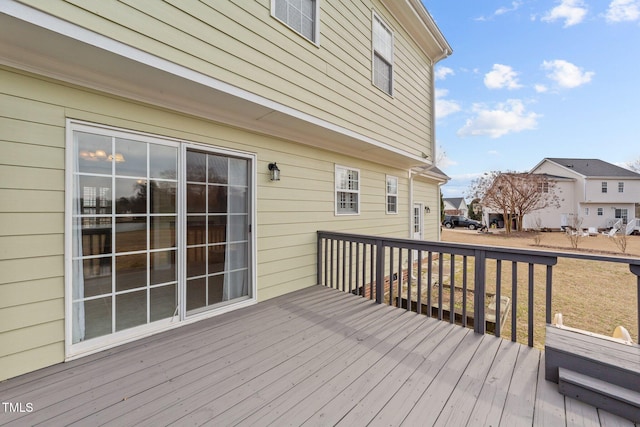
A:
[318, 231, 640, 266]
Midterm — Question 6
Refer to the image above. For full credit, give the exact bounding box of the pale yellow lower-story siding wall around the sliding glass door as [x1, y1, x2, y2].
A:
[0, 68, 422, 379]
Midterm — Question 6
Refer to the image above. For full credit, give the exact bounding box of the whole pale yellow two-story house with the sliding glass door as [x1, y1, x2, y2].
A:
[0, 0, 451, 380]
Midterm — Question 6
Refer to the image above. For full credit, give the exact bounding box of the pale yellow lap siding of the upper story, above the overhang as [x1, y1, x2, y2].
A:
[15, 0, 435, 159]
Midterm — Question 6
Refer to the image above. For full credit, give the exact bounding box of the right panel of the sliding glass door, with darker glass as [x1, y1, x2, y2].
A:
[186, 149, 250, 314]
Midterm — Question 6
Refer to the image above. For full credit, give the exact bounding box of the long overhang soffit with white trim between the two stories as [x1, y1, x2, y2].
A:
[0, 0, 430, 168]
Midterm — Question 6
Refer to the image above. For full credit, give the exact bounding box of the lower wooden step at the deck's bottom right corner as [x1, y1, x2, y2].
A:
[558, 367, 640, 423]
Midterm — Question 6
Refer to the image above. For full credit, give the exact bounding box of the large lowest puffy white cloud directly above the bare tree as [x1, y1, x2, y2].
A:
[458, 99, 541, 138]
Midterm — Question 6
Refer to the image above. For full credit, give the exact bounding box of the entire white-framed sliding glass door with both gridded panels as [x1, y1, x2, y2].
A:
[67, 124, 253, 353]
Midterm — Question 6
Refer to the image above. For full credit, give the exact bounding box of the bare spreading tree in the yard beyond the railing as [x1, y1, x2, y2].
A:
[470, 171, 560, 233]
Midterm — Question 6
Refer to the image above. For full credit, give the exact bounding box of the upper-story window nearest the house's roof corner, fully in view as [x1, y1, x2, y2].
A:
[372, 13, 393, 95]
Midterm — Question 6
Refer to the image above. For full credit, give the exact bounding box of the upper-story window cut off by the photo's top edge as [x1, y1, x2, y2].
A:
[271, 0, 319, 43]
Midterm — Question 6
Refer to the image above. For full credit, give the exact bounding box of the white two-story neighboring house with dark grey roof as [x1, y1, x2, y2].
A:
[524, 158, 640, 230]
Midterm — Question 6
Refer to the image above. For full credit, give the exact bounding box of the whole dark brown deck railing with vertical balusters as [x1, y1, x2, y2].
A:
[317, 231, 640, 347]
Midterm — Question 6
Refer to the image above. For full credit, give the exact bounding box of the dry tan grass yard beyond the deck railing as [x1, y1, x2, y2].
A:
[442, 229, 640, 348]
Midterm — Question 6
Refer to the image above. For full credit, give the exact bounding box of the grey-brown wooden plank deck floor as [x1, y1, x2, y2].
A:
[0, 286, 633, 426]
